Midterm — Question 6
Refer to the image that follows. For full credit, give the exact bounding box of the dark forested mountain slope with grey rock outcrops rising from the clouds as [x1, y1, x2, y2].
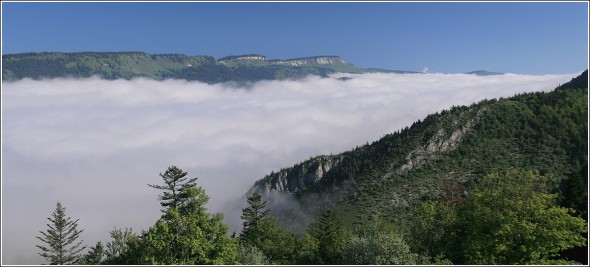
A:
[247, 71, 588, 237]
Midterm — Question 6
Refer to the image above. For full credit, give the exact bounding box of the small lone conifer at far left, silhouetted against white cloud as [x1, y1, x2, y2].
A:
[36, 202, 86, 265]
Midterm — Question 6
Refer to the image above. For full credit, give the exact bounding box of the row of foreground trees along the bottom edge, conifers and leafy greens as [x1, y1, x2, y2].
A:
[37, 166, 587, 265]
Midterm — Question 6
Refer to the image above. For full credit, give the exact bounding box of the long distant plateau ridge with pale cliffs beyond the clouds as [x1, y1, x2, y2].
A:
[2, 52, 413, 83]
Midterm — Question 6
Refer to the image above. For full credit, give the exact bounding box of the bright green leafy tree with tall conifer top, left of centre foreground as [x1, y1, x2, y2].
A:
[121, 166, 238, 265]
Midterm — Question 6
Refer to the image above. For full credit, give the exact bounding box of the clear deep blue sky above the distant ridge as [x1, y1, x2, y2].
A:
[2, 2, 588, 74]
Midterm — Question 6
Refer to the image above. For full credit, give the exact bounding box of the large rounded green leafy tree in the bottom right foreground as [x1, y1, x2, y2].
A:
[461, 169, 587, 264]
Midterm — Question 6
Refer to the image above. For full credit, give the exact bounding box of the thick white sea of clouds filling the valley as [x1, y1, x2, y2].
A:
[2, 74, 577, 264]
